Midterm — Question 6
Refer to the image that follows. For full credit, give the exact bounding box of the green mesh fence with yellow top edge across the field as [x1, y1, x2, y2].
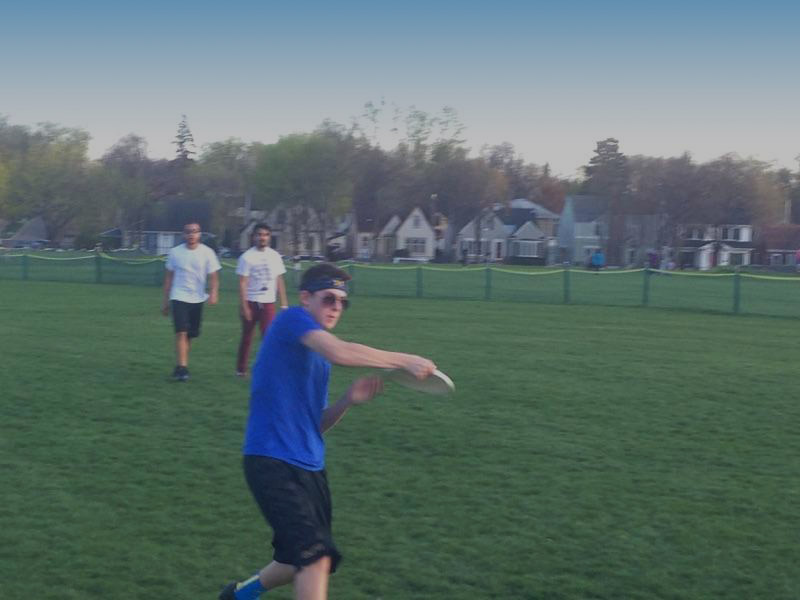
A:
[0, 253, 800, 317]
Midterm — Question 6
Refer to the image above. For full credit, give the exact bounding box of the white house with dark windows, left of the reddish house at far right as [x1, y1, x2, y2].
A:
[677, 224, 754, 270]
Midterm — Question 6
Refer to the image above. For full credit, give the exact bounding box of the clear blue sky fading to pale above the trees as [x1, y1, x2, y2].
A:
[0, 0, 800, 176]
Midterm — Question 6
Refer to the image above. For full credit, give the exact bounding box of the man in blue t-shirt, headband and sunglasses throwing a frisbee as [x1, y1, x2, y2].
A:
[219, 263, 436, 600]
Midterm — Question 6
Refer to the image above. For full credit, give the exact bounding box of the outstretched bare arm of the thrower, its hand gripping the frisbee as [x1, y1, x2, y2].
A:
[300, 329, 436, 379]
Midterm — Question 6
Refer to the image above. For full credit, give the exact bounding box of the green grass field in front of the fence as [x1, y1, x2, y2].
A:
[0, 281, 800, 600]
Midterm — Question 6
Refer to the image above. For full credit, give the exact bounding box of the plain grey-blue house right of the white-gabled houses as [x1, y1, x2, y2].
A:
[558, 196, 609, 264]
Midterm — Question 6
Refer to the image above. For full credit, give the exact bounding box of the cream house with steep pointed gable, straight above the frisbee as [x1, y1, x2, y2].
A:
[375, 207, 437, 261]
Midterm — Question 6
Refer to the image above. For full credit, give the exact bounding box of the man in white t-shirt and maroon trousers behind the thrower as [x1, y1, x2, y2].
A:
[236, 223, 289, 377]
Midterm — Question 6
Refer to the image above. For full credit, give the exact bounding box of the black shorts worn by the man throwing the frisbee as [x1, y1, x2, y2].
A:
[243, 455, 342, 573]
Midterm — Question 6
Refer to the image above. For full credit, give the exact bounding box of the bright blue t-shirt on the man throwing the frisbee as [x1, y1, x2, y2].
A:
[243, 306, 331, 471]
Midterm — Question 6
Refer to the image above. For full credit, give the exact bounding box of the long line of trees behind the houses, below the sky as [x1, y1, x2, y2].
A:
[0, 103, 800, 251]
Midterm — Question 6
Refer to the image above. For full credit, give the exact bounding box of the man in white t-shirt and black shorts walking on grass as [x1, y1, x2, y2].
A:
[161, 221, 222, 381]
